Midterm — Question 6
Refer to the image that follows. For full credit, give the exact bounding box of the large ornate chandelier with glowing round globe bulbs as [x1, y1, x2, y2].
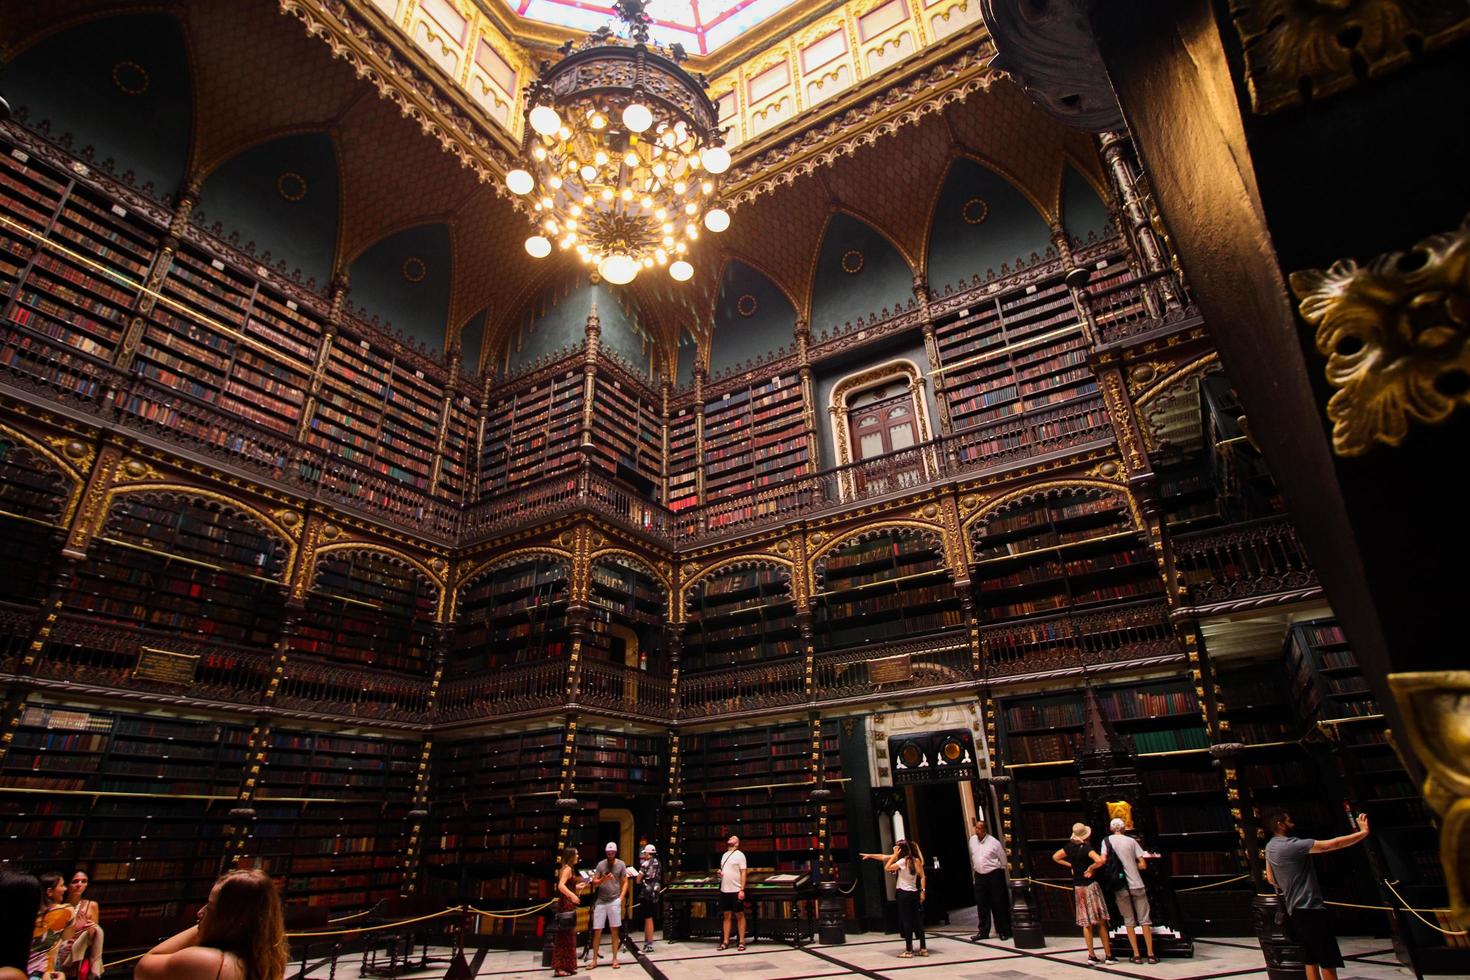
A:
[506, 0, 731, 285]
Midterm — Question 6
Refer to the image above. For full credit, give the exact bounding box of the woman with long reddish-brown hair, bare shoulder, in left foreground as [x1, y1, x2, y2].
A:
[132, 870, 287, 980]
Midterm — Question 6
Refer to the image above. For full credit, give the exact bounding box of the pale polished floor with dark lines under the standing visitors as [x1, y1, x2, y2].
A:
[313, 929, 1413, 980]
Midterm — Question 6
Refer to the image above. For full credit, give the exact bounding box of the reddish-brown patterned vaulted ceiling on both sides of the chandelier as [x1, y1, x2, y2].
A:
[0, 0, 1103, 373]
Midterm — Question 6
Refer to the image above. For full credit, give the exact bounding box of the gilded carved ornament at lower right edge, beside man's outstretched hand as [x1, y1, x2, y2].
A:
[1388, 670, 1470, 929]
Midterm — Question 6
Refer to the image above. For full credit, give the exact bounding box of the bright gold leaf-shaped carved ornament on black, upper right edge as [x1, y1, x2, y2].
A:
[1291, 217, 1470, 457]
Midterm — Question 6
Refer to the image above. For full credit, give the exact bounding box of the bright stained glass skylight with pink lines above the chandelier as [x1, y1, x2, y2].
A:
[513, 0, 797, 54]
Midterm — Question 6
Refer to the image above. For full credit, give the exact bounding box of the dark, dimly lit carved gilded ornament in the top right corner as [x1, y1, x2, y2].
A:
[1235, 0, 1470, 113]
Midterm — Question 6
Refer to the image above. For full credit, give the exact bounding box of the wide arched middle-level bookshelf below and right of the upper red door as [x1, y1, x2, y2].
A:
[972, 488, 1163, 623]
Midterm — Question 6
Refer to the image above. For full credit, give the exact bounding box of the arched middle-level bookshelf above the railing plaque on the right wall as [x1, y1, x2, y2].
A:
[811, 529, 963, 649]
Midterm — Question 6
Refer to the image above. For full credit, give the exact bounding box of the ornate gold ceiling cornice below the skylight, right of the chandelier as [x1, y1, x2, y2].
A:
[725, 35, 1005, 210]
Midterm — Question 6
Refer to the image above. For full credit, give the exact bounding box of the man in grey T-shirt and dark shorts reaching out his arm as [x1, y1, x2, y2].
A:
[1266, 811, 1369, 980]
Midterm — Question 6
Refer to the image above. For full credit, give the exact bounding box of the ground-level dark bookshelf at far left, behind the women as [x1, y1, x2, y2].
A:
[0, 698, 250, 923]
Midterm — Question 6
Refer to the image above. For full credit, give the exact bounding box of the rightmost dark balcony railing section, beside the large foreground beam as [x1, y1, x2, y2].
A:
[1173, 514, 1322, 608]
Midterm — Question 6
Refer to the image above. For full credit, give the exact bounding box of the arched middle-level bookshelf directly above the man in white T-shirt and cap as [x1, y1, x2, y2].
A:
[681, 563, 801, 673]
